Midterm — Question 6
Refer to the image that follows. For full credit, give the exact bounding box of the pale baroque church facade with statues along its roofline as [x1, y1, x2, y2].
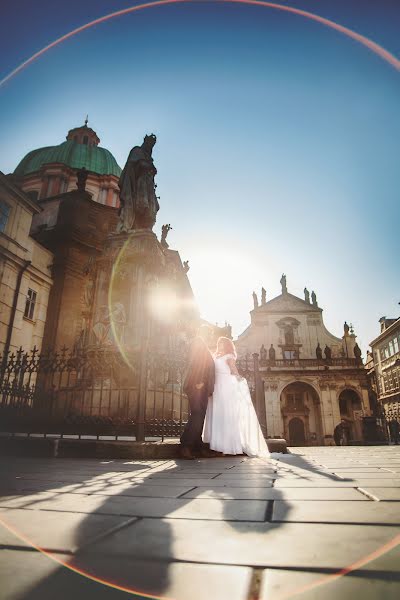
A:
[236, 276, 370, 445]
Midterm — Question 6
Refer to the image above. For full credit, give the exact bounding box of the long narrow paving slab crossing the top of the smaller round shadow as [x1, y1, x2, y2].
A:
[183, 486, 368, 502]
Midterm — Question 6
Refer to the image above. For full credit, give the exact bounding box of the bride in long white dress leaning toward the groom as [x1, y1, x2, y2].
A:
[203, 337, 270, 457]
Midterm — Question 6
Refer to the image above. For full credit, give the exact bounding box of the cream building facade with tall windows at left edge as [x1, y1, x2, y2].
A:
[0, 173, 53, 354]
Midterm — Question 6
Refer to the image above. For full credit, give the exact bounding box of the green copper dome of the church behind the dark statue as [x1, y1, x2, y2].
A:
[14, 139, 121, 177]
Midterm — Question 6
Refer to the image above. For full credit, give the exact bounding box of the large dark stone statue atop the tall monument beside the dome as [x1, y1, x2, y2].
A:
[117, 133, 160, 233]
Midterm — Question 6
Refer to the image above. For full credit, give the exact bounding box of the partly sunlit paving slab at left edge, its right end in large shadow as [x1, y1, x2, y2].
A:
[0, 508, 133, 552]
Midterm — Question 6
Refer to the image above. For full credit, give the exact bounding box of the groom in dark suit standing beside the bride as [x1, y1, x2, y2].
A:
[181, 331, 215, 460]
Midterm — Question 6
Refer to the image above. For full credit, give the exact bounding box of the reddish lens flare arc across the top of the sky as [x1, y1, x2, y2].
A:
[0, 0, 400, 87]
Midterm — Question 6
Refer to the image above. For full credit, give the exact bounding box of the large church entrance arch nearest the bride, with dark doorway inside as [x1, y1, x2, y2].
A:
[280, 381, 323, 446]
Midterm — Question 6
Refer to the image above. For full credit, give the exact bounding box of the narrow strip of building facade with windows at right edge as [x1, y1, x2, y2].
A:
[368, 317, 400, 420]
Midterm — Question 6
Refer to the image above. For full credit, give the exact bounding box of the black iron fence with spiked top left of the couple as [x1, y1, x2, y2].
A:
[0, 348, 188, 440]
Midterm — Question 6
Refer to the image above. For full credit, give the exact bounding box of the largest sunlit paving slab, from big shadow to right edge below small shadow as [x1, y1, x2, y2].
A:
[86, 516, 398, 569]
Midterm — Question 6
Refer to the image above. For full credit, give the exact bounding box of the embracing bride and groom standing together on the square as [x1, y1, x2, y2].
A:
[181, 335, 269, 460]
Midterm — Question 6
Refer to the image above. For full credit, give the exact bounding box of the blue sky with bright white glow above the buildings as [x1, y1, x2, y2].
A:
[0, 0, 400, 350]
